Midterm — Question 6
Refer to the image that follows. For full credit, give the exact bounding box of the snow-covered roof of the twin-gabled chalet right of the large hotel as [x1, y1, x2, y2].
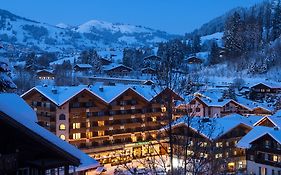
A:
[165, 114, 254, 140]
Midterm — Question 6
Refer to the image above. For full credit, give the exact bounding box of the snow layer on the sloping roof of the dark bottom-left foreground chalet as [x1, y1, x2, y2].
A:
[0, 93, 99, 171]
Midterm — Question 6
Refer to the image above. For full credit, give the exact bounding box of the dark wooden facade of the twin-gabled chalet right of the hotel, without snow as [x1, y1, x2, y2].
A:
[167, 119, 251, 174]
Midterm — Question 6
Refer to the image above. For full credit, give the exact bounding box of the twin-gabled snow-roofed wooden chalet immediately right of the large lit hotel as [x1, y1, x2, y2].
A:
[160, 114, 257, 174]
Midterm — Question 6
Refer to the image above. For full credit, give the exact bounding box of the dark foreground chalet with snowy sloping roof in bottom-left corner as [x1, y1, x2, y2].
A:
[0, 93, 99, 175]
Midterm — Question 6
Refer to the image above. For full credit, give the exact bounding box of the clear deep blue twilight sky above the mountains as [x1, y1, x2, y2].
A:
[0, 0, 263, 34]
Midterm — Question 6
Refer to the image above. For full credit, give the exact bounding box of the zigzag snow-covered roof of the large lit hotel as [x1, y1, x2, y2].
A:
[22, 83, 160, 106]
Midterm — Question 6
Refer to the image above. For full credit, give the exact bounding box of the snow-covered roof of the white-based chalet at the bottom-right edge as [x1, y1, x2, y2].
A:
[236, 126, 281, 149]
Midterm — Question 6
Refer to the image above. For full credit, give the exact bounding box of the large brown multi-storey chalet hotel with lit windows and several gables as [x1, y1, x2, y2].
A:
[22, 83, 182, 164]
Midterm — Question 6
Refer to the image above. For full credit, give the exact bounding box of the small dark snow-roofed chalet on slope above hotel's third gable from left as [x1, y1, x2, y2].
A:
[103, 63, 133, 76]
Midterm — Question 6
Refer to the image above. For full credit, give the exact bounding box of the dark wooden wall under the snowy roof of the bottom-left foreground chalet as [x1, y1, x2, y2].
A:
[0, 112, 80, 175]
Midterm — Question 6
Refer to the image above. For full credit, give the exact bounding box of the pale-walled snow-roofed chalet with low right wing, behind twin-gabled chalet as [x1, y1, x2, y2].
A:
[177, 89, 274, 117]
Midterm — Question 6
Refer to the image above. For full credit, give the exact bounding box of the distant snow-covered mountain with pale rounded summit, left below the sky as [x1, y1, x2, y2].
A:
[0, 10, 178, 52]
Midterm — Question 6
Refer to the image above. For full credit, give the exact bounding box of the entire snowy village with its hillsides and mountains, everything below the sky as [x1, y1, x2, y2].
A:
[0, 1, 281, 175]
